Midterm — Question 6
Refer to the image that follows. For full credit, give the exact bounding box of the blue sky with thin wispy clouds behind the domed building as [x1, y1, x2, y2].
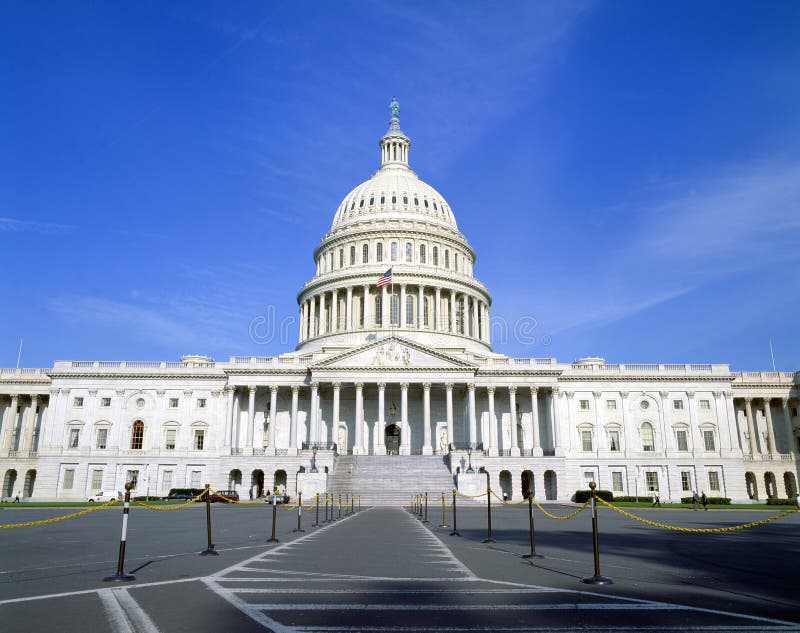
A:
[0, 0, 800, 370]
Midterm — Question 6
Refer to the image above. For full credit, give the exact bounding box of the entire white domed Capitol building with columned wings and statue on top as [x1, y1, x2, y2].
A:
[0, 100, 800, 503]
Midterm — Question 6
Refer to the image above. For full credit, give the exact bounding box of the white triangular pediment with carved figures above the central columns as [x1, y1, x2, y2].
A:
[314, 337, 475, 369]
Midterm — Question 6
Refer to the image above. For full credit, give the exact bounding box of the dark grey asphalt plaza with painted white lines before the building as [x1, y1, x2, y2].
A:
[0, 503, 800, 633]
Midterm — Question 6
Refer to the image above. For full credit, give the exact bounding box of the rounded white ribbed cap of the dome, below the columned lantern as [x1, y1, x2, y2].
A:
[331, 163, 458, 230]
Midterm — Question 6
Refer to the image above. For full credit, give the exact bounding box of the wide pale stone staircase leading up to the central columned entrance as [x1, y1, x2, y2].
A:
[328, 455, 453, 506]
